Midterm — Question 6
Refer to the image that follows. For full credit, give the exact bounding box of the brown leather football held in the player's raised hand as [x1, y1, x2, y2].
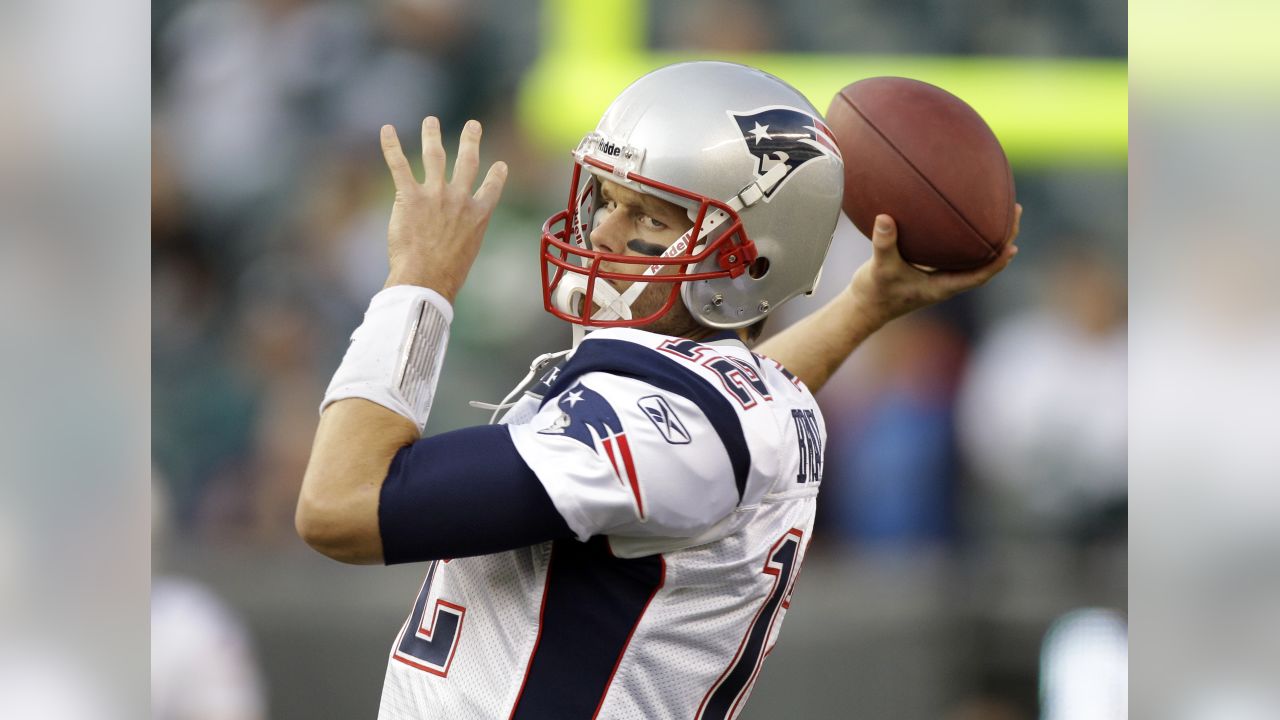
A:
[827, 77, 1014, 270]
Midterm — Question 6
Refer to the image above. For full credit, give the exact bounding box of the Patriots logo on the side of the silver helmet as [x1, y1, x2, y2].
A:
[730, 105, 842, 199]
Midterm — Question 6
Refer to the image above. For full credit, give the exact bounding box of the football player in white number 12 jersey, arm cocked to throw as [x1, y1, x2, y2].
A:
[297, 61, 1014, 720]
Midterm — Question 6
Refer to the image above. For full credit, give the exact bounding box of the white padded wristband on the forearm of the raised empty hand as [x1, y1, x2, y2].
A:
[320, 284, 453, 433]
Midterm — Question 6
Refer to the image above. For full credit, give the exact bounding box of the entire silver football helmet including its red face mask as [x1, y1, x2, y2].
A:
[541, 61, 844, 328]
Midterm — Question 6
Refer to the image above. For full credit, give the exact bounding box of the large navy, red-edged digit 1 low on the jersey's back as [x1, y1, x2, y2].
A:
[696, 528, 804, 720]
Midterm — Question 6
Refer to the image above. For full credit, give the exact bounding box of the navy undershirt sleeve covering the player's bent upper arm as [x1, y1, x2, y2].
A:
[378, 425, 573, 565]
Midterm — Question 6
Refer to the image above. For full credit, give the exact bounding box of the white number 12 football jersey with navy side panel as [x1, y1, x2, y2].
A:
[379, 329, 826, 720]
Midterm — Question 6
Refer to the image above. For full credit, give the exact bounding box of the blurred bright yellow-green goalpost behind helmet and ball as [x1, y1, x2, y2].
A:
[518, 0, 1129, 167]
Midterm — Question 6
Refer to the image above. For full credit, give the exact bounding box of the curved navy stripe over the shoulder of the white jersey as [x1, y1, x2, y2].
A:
[543, 340, 751, 502]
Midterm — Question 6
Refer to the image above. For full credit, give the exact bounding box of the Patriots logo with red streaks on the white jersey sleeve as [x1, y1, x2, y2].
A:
[538, 382, 645, 520]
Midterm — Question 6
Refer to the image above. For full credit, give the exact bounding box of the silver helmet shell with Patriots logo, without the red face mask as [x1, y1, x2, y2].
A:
[575, 61, 844, 328]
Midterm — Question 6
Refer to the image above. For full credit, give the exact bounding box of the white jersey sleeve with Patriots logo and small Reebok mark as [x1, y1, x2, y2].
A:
[511, 373, 739, 541]
